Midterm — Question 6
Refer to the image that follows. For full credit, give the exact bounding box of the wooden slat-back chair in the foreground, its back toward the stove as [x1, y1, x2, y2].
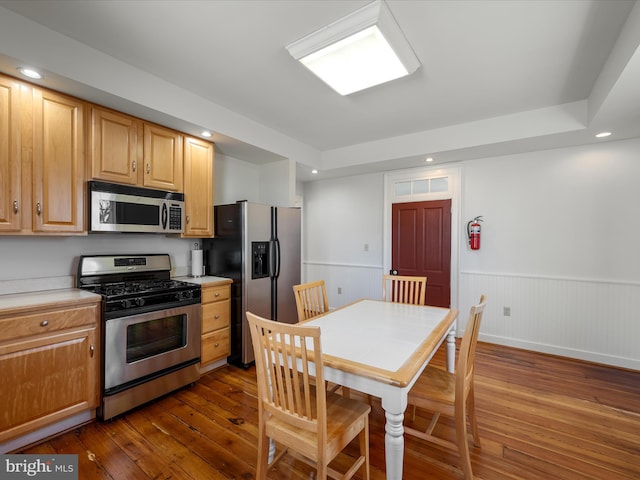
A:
[247, 312, 371, 480]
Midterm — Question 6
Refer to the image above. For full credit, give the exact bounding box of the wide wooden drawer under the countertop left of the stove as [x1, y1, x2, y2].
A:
[0, 305, 98, 341]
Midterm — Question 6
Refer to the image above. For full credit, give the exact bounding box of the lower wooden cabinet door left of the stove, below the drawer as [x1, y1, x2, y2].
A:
[0, 327, 100, 443]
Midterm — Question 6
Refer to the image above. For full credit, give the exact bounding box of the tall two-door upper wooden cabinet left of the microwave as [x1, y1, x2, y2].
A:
[0, 72, 85, 234]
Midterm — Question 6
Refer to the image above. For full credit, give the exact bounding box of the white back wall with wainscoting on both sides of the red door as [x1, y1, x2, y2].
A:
[303, 139, 640, 369]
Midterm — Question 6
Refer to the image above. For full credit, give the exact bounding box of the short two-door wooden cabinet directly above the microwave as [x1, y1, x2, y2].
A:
[89, 106, 183, 192]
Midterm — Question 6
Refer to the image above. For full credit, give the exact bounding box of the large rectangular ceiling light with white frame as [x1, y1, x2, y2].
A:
[287, 0, 420, 95]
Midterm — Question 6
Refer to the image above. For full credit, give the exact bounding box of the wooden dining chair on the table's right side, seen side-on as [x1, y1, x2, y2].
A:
[404, 295, 486, 480]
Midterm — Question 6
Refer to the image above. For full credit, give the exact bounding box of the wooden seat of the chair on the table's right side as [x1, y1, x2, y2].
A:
[408, 365, 456, 410]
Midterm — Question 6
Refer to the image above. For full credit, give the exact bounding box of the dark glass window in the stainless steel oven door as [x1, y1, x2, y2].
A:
[127, 314, 187, 363]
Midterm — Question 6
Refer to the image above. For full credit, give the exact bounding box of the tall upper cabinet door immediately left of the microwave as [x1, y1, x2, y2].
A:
[32, 89, 85, 232]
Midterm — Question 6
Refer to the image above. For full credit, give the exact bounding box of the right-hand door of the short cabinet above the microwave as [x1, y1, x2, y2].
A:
[143, 123, 183, 192]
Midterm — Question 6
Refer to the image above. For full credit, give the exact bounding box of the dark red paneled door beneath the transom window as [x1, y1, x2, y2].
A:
[391, 200, 451, 307]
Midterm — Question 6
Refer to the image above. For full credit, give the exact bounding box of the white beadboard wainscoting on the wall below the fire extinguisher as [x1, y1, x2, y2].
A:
[458, 272, 640, 370]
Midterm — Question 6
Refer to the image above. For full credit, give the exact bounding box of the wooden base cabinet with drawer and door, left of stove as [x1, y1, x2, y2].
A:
[0, 296, 100, 443]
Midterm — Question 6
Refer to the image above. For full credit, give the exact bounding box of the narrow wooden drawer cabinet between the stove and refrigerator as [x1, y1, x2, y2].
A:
[200, 280, 231, 367]
